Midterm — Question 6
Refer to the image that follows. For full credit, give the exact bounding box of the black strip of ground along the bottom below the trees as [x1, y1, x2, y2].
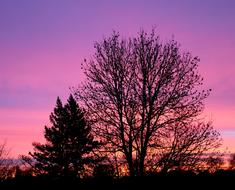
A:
[0, 173, 235, 190]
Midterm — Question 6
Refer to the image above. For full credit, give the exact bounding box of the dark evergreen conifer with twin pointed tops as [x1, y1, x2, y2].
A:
[29, 95, 98, 176]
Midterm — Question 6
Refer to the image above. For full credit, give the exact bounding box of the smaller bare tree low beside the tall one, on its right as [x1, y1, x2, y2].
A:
[148, 122, 220, 172]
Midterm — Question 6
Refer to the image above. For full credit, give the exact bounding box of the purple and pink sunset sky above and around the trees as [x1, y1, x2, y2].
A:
[0, 0, 235, 157]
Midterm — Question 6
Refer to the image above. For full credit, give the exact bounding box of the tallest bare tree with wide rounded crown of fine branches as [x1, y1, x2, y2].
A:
[75, 30, 220, 176]
